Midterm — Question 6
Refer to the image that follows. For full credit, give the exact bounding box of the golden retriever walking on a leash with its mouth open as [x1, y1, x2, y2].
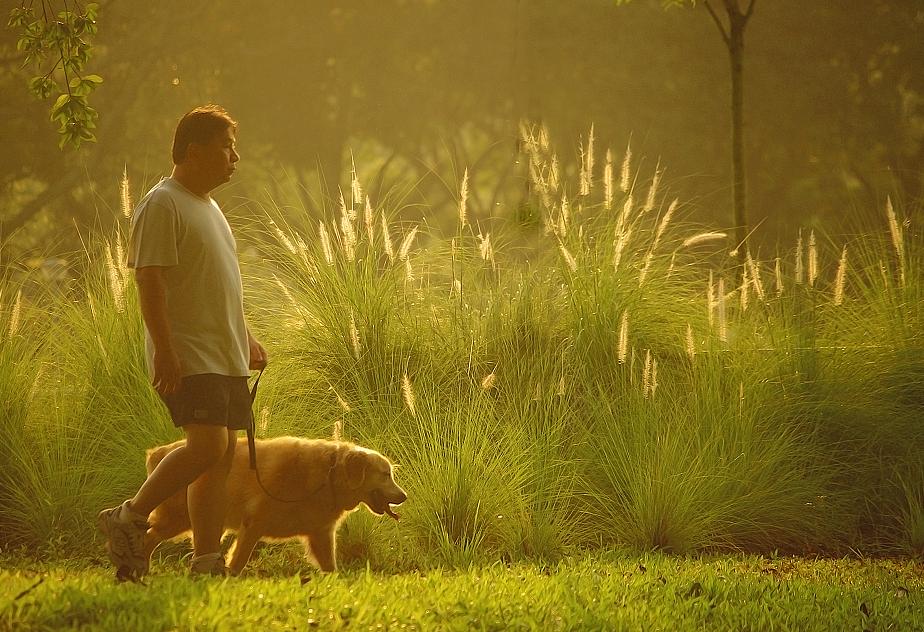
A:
[145, 437, 407, 575]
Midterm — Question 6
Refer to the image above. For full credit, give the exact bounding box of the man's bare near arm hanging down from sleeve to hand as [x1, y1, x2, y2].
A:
[135, 266, 182, 395]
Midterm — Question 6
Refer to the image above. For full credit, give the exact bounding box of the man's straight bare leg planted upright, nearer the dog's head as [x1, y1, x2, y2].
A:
[187, 428, 237, 558]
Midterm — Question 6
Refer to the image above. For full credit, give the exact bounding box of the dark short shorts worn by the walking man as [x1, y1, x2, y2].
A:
[161, 373, 253, 430]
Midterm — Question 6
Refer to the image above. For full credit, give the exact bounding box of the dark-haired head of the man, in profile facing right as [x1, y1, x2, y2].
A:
[173, 105, 240, 190]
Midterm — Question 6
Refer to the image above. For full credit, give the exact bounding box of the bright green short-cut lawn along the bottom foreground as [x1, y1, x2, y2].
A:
[0, 552, 924, 631]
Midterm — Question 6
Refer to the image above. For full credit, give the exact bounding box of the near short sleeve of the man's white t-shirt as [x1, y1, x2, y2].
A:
[128, 200, 179, 268]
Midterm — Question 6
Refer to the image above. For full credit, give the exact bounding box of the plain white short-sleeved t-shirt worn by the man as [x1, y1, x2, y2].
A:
[128, 178, 250, 376]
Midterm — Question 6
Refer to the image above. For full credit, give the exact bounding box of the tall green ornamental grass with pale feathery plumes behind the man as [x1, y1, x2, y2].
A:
[0, 127, 924, 568]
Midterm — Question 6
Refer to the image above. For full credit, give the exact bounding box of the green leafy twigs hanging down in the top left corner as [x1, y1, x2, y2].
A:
[7, 0, 103, 148]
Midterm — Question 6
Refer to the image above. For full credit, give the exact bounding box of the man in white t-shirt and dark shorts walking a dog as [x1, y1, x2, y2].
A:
[99, 105, 267, 579]
